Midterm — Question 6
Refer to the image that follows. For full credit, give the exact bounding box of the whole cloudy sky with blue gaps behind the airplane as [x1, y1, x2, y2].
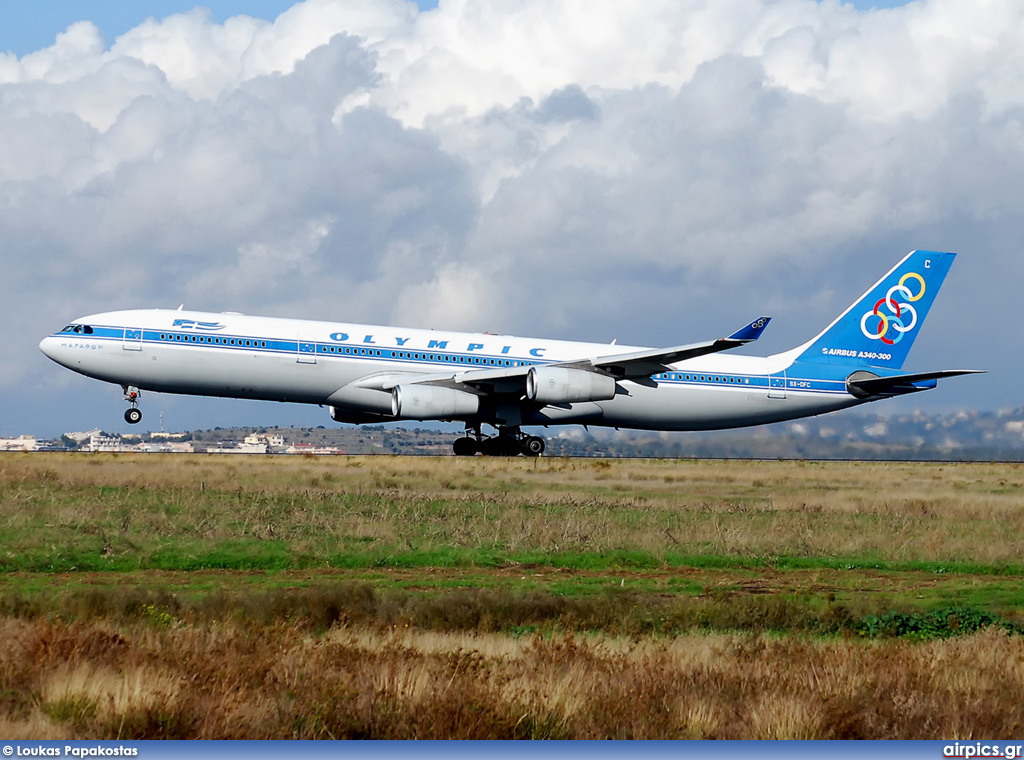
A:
[0, 0, 1024, 435]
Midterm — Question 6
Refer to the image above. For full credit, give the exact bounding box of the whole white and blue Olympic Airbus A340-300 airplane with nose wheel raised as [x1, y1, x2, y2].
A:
[39, 251, 979, 456]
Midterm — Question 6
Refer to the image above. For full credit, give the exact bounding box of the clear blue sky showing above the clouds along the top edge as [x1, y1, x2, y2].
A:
[0, 0, 909, 57]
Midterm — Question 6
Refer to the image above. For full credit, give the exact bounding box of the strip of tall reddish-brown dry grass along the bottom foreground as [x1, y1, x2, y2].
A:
[0, 621, 1024, 738]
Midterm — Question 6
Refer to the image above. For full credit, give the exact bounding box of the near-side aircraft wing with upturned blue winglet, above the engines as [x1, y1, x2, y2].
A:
[339, 316, 771, 395]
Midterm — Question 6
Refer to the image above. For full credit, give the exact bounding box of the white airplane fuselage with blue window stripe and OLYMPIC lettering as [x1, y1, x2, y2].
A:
[40, 309, 861, 430]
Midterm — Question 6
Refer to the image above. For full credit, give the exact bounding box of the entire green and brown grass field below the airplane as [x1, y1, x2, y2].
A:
[0, 454, 1024, 738]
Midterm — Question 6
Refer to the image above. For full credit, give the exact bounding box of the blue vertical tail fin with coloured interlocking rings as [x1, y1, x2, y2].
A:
[798, 251, 956, 370]
